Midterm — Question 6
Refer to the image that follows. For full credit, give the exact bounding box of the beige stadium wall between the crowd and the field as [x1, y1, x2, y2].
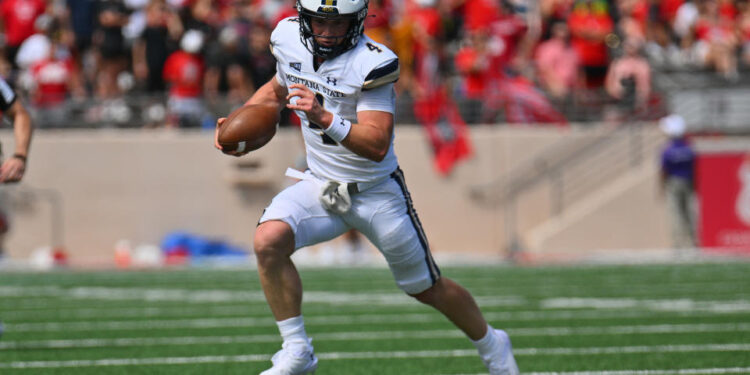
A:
[0, 126, 668, 263]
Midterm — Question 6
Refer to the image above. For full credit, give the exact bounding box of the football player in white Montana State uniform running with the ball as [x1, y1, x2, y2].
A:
[217, 0, 518, 375]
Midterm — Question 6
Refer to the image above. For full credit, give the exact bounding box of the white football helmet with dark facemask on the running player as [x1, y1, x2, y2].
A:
[297, 0, 369, 59]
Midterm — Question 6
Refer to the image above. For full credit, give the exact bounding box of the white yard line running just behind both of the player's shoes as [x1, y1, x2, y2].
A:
[0, 344, 750, 369]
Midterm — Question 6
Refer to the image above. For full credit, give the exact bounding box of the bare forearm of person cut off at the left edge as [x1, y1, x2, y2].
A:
[0, 100, 32, 183]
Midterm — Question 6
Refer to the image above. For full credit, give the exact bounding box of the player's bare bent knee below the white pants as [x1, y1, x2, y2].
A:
[253, 221, 294, 266]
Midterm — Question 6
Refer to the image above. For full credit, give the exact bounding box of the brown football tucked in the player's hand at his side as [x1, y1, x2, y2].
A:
[218, 104, 279, 152]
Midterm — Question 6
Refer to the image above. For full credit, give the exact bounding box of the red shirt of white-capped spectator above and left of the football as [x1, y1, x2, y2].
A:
[164, 50, 205, 98]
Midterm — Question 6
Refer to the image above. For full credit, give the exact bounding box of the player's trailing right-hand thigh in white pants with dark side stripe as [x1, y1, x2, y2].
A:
[358, 180, 440, 294]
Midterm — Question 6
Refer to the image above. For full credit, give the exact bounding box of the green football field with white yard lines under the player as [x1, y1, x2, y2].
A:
[0, 261, 750, 375]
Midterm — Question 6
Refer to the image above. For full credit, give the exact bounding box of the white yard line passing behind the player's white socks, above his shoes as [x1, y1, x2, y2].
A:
[0, 323, 750, 350]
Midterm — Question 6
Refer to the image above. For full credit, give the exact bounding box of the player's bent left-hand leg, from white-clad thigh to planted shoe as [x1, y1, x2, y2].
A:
[253, 180, 347, 375]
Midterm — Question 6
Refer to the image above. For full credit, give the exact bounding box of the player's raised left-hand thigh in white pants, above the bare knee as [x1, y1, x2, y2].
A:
[259, 180, 349, 250]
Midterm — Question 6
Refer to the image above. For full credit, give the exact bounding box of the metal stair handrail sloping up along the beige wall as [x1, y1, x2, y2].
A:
[470, 122, 662, 255]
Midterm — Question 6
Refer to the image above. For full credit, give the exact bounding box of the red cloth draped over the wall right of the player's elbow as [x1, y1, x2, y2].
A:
[414, 88, 472, 176]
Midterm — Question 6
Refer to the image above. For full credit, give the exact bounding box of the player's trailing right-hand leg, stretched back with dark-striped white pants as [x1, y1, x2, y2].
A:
[351, 171, 518, 375]
